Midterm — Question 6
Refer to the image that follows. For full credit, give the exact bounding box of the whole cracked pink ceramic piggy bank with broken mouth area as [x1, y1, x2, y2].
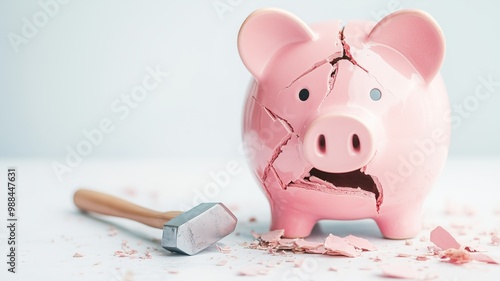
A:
[238, 9, 450, 239]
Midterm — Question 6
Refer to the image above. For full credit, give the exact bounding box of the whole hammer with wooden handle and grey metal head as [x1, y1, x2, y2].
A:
[73, 189, 238, 255]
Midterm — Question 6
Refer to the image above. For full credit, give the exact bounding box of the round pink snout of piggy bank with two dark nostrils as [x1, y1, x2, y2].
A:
[302, 112, 380, 173]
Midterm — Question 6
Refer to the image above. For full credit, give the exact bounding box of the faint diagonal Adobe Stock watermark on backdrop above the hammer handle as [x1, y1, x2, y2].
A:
[51, 65, 169, 182]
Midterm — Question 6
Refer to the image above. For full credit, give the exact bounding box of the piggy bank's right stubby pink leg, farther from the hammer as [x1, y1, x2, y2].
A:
[375, 205, 422, 239]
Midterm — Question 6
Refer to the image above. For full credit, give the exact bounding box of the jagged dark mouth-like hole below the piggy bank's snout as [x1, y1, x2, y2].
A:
[306, 168, 380, 199]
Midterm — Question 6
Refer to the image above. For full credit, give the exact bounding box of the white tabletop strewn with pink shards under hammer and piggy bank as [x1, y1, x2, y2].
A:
[0, 156, 500, 281]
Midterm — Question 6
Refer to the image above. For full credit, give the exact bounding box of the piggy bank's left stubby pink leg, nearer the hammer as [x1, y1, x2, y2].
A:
[271, 206, 317, 238]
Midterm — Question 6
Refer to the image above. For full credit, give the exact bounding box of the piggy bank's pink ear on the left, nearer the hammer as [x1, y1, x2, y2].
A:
[238, 9, 314, 81]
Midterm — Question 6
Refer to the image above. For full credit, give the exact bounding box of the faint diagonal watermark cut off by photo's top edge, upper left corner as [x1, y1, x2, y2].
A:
[7, 0, 71, 54]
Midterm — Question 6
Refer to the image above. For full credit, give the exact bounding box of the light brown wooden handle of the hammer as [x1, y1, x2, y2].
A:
[73, 189, 182, 229]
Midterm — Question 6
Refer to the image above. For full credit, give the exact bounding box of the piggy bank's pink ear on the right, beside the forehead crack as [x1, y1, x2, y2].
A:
[368, 10, 445, 83]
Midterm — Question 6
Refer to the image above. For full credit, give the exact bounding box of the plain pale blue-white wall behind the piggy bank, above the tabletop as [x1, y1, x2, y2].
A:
[0, 0, 500, 163]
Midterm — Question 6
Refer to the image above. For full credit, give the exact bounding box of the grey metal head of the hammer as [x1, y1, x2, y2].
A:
[161, 203, 238, 255]
